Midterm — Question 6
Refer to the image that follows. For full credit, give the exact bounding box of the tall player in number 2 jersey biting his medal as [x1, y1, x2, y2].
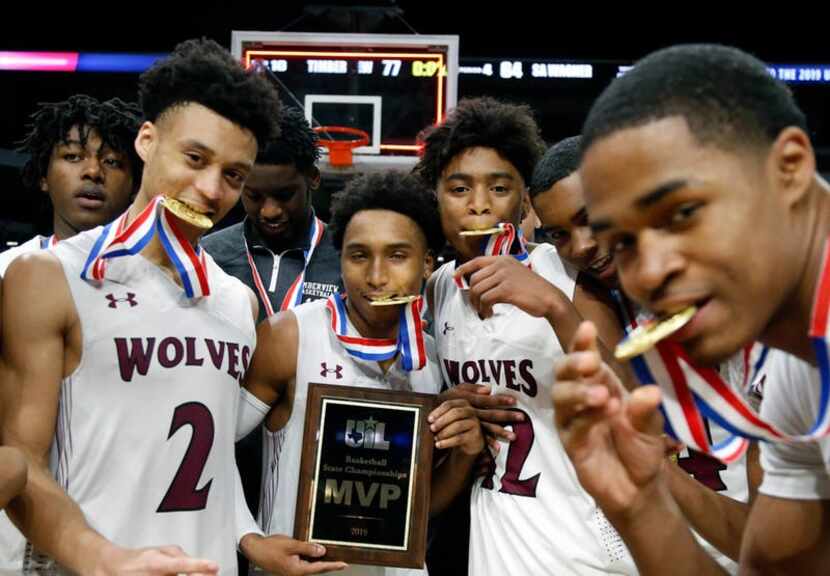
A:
[1, 40, 286, 574]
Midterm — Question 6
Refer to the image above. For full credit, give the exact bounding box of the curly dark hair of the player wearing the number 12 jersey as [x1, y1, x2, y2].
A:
[414, 97, 545, 188]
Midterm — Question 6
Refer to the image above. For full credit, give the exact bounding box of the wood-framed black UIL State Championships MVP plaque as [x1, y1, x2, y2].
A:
[295, 384, 433, 568]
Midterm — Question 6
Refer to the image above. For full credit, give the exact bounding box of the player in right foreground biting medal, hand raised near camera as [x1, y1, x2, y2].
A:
[554, 45, 830, 576]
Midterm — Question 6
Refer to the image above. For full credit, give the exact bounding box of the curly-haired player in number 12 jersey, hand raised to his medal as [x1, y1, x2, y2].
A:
[418, 98, 634, 575]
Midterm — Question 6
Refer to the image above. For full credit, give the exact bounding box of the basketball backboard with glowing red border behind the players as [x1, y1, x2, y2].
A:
[231, 31, 458, 164]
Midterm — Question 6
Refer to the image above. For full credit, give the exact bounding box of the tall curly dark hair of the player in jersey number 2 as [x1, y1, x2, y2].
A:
[138, 38, 280, 146]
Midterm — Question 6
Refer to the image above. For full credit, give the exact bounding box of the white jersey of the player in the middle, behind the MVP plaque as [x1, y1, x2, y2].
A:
[259, 300, 441, 576]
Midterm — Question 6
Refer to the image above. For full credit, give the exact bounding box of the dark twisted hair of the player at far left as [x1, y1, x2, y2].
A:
[18, 94, 144, 189]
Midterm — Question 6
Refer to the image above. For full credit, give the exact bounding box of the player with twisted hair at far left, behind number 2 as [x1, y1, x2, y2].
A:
[0, 95, 141, 570]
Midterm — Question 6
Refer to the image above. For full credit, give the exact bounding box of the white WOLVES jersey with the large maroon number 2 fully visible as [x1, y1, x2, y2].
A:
[26, 228, 256, 575]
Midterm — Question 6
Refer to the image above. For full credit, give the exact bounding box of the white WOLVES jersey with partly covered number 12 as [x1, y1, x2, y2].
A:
[433, 244, 636, 576]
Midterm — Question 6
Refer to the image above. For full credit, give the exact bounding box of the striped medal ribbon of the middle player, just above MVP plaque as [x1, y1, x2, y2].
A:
[326, 293, 427, 372]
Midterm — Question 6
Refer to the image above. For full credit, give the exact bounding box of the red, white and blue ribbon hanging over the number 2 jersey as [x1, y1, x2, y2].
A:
[81, 195, 210, 298]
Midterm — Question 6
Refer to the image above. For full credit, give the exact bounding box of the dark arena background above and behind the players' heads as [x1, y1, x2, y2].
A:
[0, 5, 830, 250]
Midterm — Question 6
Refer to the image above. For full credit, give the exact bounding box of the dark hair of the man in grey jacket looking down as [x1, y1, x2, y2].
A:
[257, 107, 320, 172]
